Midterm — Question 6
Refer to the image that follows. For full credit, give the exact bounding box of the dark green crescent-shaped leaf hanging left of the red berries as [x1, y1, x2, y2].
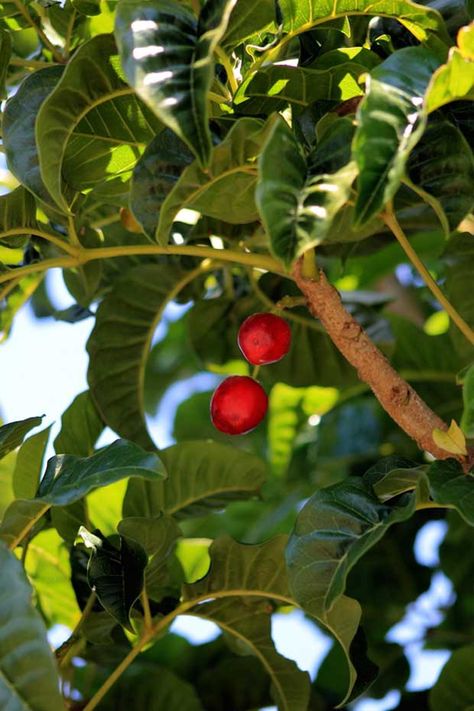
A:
[87, 264, 198, 448]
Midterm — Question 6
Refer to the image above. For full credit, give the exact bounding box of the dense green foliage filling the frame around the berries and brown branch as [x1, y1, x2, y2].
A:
[0, 0, 474, 711]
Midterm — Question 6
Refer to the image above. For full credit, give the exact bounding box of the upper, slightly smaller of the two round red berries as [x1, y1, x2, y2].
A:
[238, 314, 291, 365]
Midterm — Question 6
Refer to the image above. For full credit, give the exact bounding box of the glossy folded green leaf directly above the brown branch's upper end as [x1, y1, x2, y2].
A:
[256, 120, 356, 264]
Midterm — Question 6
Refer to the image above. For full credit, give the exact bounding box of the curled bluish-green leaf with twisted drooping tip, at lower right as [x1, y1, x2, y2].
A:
[286, 466, 415, 703]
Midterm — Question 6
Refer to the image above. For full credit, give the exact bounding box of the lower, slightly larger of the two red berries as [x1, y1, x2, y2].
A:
[211, 375, 268, 434]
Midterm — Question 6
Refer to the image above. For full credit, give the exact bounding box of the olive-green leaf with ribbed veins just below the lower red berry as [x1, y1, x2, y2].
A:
[123, 441, 266, 520]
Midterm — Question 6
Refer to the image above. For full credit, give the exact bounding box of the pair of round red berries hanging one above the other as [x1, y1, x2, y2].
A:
[211, 313, 291, 435]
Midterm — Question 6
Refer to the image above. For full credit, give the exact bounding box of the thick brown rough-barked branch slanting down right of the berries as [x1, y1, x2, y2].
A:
[293, 260, 461, 459]
